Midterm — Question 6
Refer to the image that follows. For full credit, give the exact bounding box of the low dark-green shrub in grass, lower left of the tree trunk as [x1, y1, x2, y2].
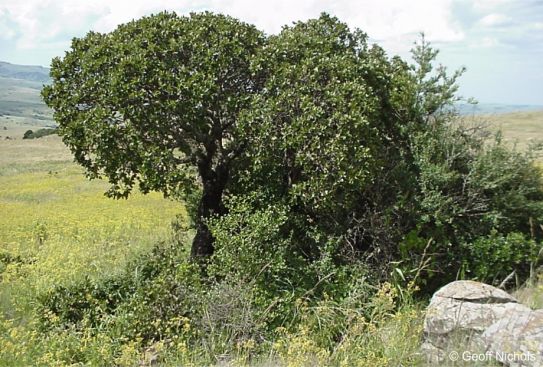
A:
[37, 244, 194, 335]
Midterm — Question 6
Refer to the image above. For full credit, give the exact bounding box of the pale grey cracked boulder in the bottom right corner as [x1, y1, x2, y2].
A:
[423, 281, 543, 366]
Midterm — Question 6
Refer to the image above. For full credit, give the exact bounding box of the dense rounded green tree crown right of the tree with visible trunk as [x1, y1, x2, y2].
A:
[234, 14, 418, 262]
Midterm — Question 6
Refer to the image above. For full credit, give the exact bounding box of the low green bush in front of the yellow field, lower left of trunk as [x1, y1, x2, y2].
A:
[38, 244, 198, 340]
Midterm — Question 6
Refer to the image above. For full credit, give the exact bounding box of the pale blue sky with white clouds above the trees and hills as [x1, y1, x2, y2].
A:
[0, 0, 543, 105]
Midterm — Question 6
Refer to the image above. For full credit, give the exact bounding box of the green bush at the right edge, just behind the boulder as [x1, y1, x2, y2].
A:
[410, 124, 543, 293]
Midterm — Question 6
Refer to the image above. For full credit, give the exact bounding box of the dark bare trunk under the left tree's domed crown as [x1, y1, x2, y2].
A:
[191, 164, 228, 259]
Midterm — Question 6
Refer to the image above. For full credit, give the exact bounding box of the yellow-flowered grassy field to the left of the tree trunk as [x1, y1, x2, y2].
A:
[0, 132, 186, 366]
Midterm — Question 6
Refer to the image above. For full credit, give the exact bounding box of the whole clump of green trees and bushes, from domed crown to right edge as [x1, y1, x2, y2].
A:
[43, 13, 543, 274]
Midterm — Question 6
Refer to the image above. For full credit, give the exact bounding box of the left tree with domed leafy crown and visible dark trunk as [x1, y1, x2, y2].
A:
[43, 12, 264, 257]
